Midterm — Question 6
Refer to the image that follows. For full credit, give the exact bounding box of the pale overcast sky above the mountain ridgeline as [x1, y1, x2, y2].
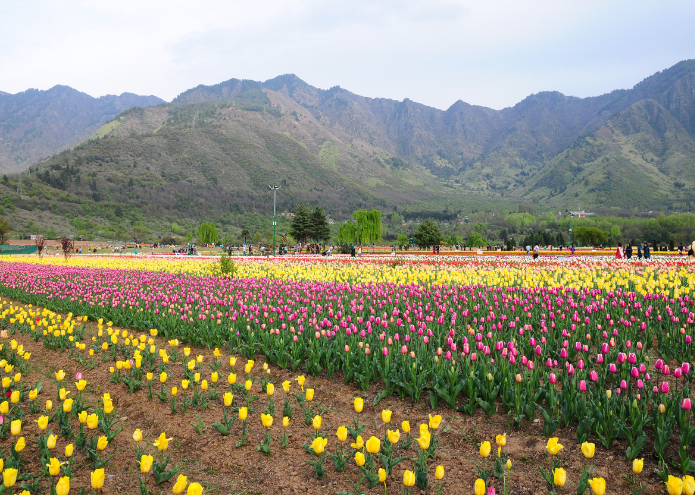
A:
[0, 0, 695, 109]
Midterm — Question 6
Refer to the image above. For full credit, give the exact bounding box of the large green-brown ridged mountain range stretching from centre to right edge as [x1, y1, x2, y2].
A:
[0, 60, 695, 242]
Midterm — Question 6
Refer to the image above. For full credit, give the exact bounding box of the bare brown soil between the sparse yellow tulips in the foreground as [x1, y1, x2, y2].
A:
[0, 303, 664, 495]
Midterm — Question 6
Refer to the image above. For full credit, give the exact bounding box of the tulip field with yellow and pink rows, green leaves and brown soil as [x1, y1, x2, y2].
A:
[0, 256, 695, 495]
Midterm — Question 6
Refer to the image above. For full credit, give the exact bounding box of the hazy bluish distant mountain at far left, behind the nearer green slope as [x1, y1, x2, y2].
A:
[0, 86, 163, 173]
